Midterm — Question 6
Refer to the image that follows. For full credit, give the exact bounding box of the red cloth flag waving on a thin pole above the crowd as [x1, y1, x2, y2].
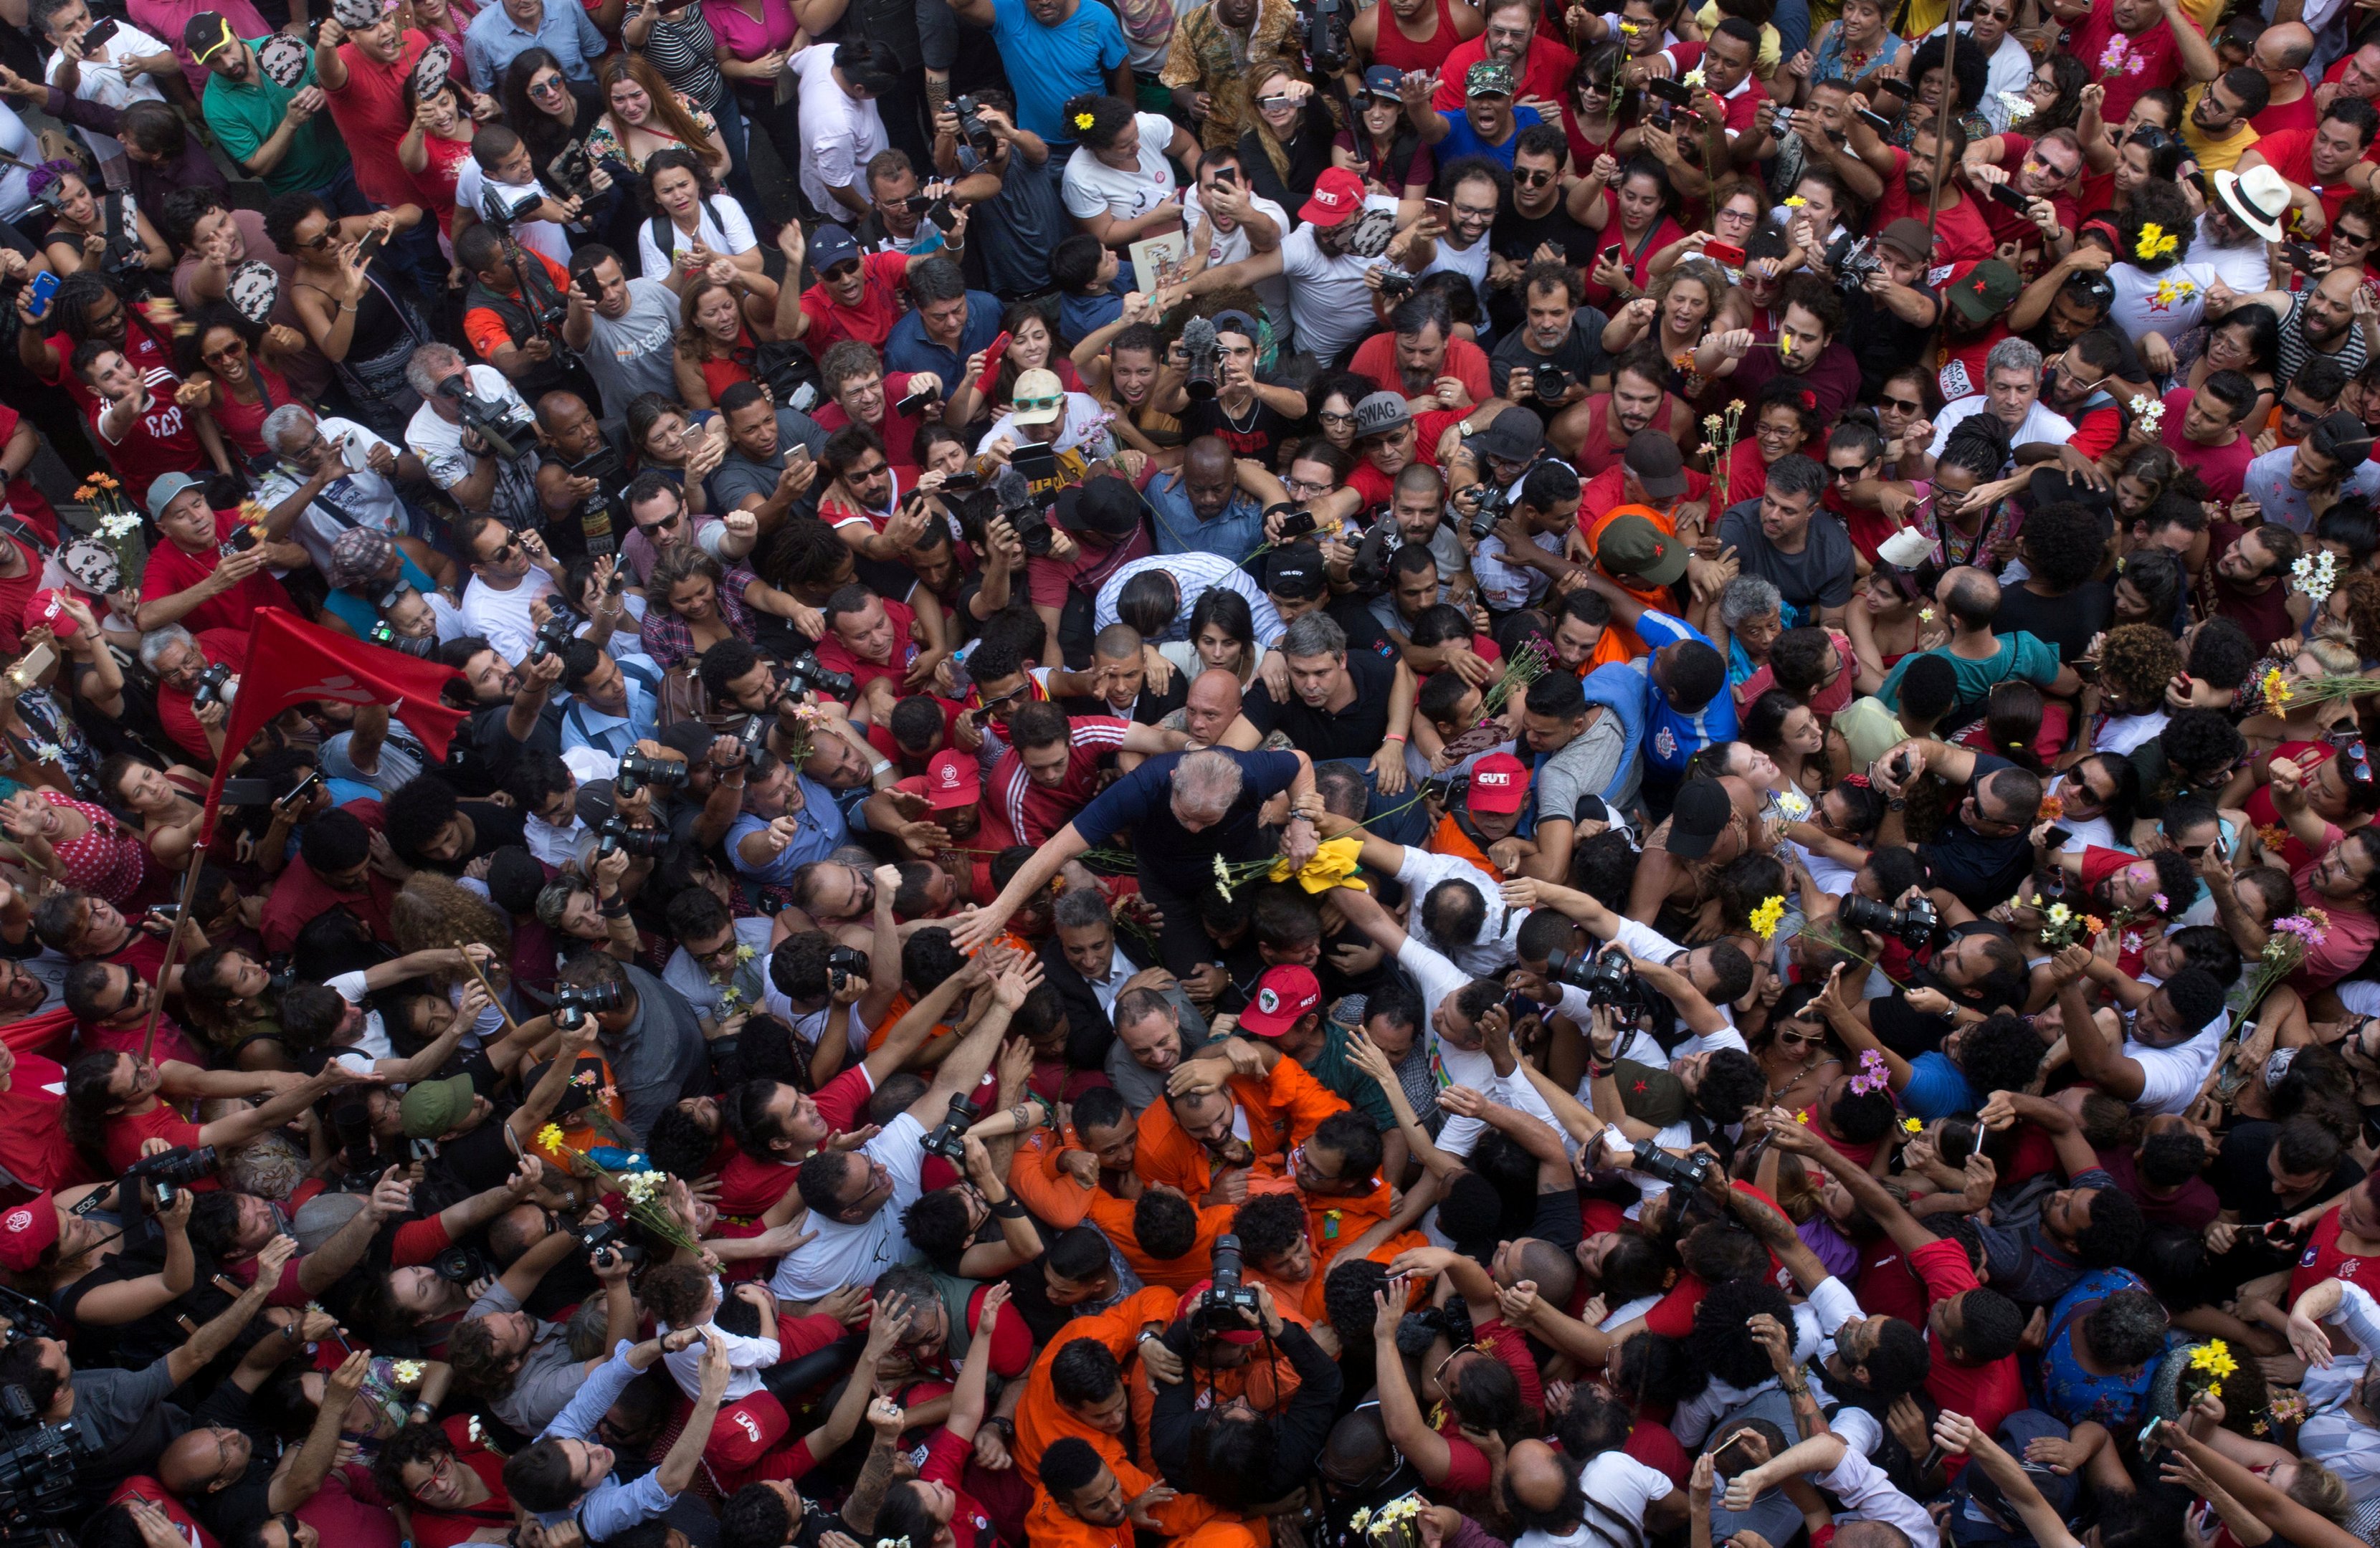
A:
[200, 606, 464, 844]
